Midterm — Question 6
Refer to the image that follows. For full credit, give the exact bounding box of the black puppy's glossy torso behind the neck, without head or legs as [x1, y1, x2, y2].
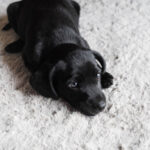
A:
[12, 0, 88, 71]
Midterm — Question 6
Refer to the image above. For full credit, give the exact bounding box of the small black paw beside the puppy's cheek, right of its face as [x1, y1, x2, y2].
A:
[101, 72, 114, 88]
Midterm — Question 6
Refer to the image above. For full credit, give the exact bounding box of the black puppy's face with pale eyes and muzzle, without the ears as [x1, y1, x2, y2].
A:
[54, 50, 106, 116]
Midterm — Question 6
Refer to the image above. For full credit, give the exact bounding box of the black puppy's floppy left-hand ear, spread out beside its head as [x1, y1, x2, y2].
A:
[30, 62, 66, 100]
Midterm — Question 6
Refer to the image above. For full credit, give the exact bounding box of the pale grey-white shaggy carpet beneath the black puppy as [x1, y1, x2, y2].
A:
[0, 0, 150, 150]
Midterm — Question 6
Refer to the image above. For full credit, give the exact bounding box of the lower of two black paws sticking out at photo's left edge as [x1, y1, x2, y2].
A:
[5, 39, 24, 53]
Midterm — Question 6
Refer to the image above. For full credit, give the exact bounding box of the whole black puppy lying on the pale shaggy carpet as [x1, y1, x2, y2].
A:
[3, 0, 113, 115]
